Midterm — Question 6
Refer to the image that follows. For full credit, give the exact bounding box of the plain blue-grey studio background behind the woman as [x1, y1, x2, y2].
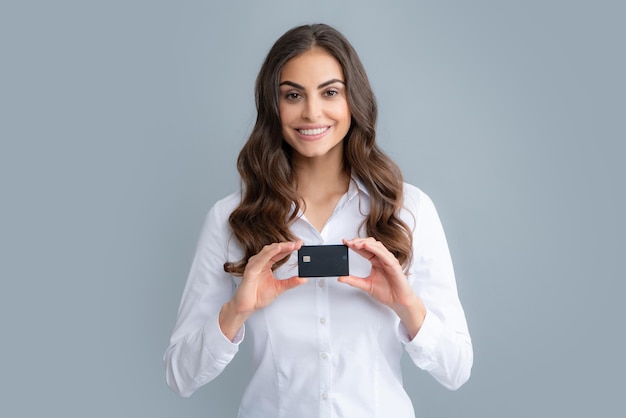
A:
[0, 0, 626, 417]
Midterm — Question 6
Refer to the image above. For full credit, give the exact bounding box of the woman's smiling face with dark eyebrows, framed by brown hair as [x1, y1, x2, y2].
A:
[279, 48, 351, 162]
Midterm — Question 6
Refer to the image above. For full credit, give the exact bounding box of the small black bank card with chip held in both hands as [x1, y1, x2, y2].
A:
[298, 245, 350, 277]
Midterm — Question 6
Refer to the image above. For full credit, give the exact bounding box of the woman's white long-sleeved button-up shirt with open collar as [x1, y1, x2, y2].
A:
[164, 179, 473, 418]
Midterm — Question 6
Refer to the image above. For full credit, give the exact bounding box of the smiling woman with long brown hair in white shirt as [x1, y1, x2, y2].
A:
[164, 24, 473, 418]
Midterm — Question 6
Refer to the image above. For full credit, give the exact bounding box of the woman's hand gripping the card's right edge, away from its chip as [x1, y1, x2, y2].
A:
[339, 238, 426, 339]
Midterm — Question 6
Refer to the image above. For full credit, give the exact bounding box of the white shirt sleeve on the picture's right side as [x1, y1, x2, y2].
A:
[398, 191, 473, 390]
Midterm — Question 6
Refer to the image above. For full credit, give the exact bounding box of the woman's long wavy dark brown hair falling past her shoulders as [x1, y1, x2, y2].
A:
[224, 24, 412, 276]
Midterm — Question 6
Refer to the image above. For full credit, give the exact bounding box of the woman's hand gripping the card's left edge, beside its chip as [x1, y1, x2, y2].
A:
[219, 241, 306, 341]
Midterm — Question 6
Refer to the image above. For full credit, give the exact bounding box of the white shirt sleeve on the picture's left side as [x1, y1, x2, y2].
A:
[163, 198, 245, 397]
